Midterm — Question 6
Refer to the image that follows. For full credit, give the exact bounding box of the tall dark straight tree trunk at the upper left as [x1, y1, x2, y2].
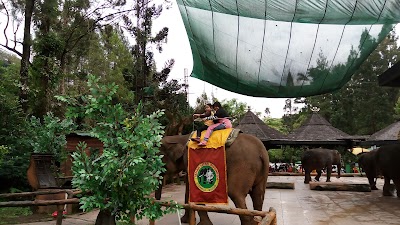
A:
[19, 0, 35, 113]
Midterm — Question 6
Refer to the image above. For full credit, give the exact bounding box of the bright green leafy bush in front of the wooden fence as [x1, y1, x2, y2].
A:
[59, 76, 178, 221]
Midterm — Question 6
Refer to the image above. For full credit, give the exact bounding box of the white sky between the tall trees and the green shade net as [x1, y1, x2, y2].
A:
[153, 0, 286, 118]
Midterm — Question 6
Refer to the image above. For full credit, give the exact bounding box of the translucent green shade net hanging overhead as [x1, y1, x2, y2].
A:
[177, 0, 400, 97]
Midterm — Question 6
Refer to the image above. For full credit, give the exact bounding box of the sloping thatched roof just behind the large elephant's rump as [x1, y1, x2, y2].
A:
[236, 110, 285, 141]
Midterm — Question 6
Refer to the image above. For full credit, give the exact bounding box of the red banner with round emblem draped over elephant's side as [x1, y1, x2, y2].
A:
[188, 146, 228, 204]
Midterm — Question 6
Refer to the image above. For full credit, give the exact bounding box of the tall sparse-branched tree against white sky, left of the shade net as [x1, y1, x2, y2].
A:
[123, 0, 174, 104]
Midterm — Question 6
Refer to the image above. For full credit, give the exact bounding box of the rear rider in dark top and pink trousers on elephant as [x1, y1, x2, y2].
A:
[199, 102, 232, 146]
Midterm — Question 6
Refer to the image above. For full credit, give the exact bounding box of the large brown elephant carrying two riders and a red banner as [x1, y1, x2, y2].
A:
[156, 133, 269, 225]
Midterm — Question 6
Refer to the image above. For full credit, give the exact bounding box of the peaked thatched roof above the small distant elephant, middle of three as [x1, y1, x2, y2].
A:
[287, 112, 352, 141]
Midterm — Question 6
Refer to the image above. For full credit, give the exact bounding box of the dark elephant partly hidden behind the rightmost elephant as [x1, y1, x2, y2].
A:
[358, 149, 378, 190]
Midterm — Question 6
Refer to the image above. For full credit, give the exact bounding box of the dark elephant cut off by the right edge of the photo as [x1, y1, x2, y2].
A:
[376, 144, 400, 198]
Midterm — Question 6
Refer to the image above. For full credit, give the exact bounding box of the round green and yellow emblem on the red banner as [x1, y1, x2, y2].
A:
[194, 162, 219, 192]
